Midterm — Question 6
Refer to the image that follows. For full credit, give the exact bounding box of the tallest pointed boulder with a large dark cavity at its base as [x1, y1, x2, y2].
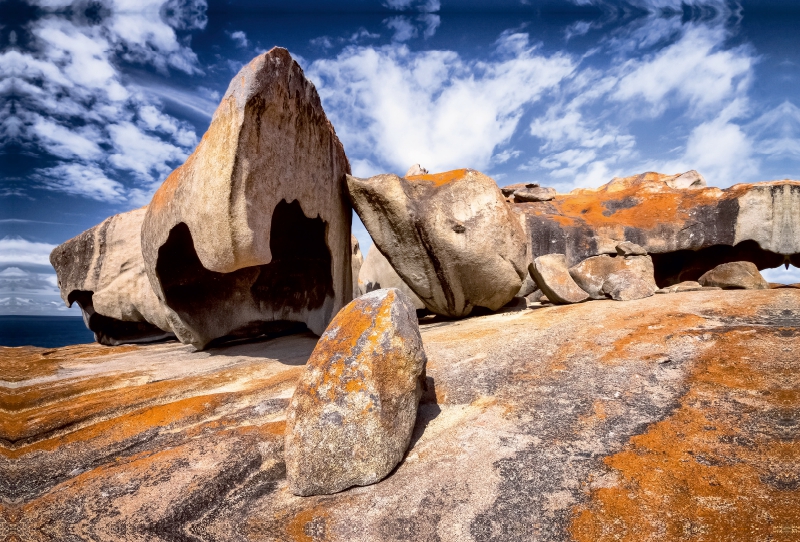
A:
[142, 48, 352, 348]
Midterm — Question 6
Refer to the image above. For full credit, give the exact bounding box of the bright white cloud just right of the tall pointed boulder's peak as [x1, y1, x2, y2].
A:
[308, 34, 574, 173]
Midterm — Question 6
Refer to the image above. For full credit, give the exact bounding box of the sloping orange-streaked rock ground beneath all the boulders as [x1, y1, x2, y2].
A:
[0, 289, 800, 541]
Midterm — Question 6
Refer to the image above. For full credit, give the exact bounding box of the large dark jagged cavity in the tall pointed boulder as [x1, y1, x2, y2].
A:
[156, 200, 333, 344]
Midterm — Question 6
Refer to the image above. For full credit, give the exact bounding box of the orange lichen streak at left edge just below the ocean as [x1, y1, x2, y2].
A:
[0, 343, 141, 382]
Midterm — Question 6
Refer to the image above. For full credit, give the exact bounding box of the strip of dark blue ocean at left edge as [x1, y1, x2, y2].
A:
[0, 316, 94, 348]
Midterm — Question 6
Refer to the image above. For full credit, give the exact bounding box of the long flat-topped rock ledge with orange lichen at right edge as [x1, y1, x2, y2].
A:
[513, 171, 800, 287]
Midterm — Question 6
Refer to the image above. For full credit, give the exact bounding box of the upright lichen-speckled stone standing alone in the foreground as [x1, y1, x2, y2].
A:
[285, 288, 426, 496]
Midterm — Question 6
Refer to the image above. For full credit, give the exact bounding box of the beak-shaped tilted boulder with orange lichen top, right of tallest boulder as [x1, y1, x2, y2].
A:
[347, 169, 527, 317]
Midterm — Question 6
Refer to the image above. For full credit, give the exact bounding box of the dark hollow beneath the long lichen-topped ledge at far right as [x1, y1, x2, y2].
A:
[650, 241, 785, 288]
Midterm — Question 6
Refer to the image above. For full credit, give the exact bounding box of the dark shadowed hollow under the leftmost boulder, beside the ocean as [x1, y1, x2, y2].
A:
[67, 290, 175, 346]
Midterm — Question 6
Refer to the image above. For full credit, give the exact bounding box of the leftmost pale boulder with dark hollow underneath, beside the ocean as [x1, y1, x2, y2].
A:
[50, 208, 174, 345]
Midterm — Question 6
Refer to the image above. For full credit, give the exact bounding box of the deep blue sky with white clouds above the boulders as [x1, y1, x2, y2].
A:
[0, 0, 800, 314]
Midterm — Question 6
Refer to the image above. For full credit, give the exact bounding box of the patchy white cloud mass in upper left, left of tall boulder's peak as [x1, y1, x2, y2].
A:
[0, 0, 208, 203]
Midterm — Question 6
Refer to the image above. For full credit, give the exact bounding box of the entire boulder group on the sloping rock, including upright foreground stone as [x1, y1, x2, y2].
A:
[51, 48, 800, 495]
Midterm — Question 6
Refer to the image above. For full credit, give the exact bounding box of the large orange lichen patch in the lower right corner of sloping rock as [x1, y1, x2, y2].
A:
[570, 329, 800, 542]
